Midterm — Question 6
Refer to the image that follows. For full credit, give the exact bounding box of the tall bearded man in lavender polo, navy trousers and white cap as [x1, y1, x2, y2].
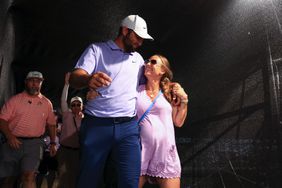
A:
[70, 15, 153, 188]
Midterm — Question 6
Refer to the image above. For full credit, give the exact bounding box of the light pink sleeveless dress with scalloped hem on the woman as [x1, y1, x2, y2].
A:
[137, 85, 181, 178]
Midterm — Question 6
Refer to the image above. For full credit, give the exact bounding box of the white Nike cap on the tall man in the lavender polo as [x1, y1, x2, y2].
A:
[121, 15, 154, 40]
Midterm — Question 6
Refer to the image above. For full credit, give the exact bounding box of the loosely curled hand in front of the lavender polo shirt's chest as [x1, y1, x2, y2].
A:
[88, 72, 112, 90]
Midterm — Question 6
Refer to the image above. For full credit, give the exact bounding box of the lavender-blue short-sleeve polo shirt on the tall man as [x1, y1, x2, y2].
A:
[75, 40, 144, 117]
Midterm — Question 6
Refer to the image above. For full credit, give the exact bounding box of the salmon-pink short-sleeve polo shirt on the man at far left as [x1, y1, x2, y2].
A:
[0, 91, 56, 137]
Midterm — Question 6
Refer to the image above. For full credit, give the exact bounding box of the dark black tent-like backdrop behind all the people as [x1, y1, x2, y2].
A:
[0, 0, 282, 188]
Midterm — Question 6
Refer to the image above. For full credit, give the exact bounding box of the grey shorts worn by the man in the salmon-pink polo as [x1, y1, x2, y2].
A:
[0, 138, 44, 178]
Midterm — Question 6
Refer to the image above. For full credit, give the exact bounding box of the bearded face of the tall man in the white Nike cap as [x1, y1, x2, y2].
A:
[123, 29, 144, 53]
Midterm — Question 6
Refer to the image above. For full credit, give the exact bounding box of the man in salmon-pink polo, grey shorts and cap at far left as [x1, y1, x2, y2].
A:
[0, 71, 56, 188]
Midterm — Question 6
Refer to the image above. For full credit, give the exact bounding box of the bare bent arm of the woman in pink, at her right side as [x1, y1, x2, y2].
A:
[172, 83, 188, 127]
